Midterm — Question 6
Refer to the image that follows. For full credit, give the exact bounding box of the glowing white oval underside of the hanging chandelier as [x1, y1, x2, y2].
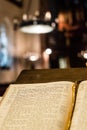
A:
[20, 24, 54, 34]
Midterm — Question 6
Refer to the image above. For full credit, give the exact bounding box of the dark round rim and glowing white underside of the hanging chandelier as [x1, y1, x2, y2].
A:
[20, 20, 55, 34]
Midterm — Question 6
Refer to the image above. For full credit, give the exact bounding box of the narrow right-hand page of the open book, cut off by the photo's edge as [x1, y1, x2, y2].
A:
[70, 81, 87, 130]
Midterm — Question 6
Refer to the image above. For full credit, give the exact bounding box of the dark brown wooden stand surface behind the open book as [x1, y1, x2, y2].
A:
[16, 68, 87, 84]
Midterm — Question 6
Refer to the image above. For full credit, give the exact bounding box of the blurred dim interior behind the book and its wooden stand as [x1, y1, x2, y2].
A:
[0, 0, 87, 85]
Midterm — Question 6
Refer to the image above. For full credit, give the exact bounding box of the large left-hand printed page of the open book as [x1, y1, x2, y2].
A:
[0, 81, 73, 130]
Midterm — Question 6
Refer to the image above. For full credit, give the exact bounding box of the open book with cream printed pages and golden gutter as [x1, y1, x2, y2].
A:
[0, 81, 87, 130]
